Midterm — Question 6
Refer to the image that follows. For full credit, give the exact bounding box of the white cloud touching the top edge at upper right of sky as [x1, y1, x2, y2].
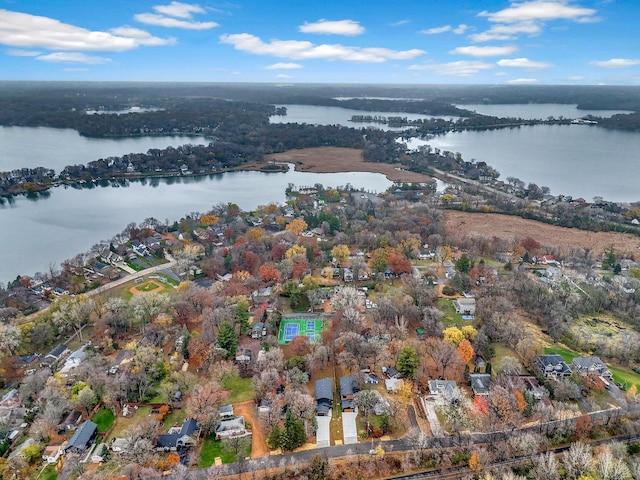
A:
[478, 0, 596, 23]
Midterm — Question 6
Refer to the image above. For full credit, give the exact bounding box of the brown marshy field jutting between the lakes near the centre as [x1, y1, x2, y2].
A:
[262, 147, 430, 183]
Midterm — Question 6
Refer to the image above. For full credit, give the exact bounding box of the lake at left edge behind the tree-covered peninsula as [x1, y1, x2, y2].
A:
[0, 126, 205, 172]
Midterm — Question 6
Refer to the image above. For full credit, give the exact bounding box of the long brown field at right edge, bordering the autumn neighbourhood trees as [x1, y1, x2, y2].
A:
[442, 210, 640, 255]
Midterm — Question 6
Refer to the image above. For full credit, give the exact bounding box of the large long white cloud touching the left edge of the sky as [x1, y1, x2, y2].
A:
[0, 9, 175, 52]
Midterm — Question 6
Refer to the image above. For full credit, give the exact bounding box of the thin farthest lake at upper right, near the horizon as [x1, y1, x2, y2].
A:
[456, 103, 632, 120]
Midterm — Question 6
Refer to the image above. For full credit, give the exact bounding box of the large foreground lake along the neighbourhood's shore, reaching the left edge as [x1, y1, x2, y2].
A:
[0, 170, 391, 283]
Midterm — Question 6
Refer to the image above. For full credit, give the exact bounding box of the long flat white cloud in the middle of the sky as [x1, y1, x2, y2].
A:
[220, 33, 426, 63]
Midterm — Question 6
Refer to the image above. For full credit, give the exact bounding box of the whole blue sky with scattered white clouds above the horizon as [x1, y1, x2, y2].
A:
[0, 0, 640, 85]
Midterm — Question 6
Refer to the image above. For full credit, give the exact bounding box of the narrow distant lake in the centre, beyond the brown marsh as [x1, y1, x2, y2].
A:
[270, 105, 458, 131]
